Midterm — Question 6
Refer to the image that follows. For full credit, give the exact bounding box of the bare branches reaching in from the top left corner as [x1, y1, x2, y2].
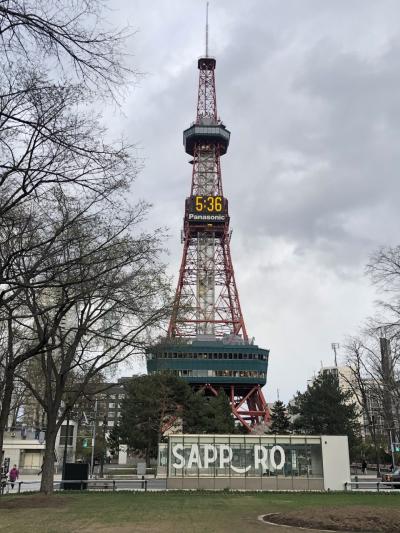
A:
[0, 0, 131, 92]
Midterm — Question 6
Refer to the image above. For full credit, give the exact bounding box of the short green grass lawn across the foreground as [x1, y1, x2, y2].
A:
[0, 491, 400, 533]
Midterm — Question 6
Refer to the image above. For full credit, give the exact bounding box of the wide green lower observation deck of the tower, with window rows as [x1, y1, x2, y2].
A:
[147, 336, 269, 389]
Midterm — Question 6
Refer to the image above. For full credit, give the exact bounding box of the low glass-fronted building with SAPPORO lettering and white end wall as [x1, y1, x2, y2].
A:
[157, 434, 350, 491]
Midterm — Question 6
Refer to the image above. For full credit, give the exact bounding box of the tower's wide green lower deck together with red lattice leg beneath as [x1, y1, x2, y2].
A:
[147, 335, 269, 431]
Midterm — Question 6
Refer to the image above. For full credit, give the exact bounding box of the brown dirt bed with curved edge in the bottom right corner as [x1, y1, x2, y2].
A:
[264, 506, 400, 533]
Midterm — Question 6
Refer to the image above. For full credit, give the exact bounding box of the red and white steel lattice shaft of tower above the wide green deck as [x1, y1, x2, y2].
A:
[168, 58, 248, 340]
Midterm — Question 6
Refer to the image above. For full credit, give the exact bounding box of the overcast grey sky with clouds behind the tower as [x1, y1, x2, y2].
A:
[106, 0, 400, 401]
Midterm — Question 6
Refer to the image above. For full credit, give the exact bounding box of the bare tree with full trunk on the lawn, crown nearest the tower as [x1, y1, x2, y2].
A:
[10, 192, 169, 492]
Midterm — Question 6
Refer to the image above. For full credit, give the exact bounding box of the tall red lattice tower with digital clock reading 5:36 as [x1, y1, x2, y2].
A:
[147, 9, 269, 431]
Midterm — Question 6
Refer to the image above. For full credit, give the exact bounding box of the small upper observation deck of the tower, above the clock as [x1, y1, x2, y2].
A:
[183, 119, 231, 156]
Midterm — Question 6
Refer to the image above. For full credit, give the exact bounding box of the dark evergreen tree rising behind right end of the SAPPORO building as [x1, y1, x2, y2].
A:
[291, 374, 359, 456]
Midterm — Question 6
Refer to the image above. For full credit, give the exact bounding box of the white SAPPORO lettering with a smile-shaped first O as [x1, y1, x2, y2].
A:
[172, 444, 286, 474]
